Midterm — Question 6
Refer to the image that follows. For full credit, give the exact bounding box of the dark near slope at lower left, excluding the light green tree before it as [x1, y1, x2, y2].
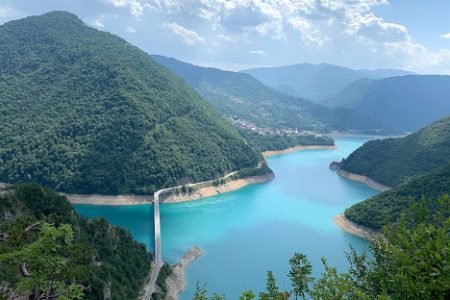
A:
[0, 184, 152, 300]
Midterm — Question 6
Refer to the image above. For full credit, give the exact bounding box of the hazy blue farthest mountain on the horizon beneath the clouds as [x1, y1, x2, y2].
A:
[242, 64, 412, 102]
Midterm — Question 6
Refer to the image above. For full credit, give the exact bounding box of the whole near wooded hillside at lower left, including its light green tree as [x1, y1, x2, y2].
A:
[0, 184, 152, 300]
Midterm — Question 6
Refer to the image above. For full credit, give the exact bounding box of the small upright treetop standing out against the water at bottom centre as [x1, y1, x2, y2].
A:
[288, 252, 313, 299]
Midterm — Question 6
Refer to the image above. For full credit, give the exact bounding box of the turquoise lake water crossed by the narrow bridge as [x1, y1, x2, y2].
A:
[76, 138, 376, 300]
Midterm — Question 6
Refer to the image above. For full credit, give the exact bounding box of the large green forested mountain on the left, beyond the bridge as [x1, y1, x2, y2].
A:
[0, 12, 262, 194]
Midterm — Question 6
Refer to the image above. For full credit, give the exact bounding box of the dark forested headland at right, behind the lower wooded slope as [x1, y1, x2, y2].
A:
[340, 117, 450, 186]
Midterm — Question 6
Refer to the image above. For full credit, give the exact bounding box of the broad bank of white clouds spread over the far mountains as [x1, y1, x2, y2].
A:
[104, 0, 450, 73]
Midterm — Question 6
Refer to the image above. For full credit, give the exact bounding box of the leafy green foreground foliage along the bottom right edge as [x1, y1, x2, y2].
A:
[194, 197, 450, 300]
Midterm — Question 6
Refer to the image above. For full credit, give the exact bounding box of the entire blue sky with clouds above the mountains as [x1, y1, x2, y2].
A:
[0, 0, 450, 74]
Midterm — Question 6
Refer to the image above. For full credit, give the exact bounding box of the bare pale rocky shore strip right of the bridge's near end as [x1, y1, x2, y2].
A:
[166, 247, 203, 300]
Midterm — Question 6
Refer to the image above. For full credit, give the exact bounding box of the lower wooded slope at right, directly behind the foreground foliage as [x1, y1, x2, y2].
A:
[345, 164, 450, 230]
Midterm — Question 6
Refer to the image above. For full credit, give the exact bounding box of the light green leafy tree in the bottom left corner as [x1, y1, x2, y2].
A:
[0, 223, 83, 300]
